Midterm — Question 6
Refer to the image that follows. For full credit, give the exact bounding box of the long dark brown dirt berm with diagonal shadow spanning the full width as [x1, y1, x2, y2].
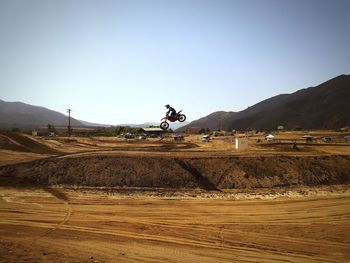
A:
[0, 155, 350, 190]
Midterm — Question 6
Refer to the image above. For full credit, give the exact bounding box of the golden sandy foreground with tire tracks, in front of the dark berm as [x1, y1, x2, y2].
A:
[0, 188, 350, 262]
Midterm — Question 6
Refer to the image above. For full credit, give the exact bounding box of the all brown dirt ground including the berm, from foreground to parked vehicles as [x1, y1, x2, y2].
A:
[0, 131, 350, 263]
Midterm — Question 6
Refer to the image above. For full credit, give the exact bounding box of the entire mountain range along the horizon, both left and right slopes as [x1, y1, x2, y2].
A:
[0, 75, 350, 131]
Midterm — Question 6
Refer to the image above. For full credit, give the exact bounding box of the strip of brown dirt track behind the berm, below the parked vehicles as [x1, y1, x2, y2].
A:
[0, 131, 350, 166]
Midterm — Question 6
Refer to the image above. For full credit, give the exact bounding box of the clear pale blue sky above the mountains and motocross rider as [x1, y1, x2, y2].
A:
[0, 0, 350, 124]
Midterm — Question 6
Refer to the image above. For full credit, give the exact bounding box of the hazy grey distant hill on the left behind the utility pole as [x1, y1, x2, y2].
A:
[0, 100, 84, 129]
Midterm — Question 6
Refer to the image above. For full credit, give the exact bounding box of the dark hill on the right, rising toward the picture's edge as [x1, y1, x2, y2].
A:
[181, 75, 350, 130]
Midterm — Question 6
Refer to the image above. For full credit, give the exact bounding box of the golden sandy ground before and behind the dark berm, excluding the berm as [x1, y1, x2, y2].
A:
[0, 132, 350, 263]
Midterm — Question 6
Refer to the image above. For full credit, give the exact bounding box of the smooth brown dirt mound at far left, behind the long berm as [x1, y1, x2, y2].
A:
[0, 131, 60, 154]
